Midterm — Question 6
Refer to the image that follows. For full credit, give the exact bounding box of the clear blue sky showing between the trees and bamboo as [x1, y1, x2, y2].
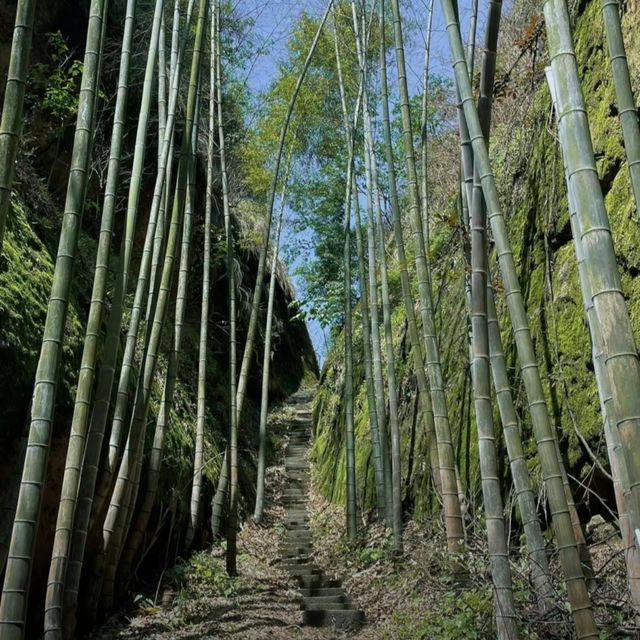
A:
[236, 0, 485, 361]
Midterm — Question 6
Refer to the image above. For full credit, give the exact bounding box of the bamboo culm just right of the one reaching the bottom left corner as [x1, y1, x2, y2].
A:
[45, 0, 137, 640]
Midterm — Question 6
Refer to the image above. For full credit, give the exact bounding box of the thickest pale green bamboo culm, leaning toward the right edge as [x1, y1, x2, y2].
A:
[544, 0, 640, 556]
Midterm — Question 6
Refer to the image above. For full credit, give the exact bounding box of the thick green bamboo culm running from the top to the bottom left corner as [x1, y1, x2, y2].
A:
[0, 0, 108, 640]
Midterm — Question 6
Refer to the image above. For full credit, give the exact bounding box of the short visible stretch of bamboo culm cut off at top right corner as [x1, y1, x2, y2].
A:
[601, 0, 640, 211]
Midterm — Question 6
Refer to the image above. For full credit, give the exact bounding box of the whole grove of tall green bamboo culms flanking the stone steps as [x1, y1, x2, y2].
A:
[0, 0, 640, 640]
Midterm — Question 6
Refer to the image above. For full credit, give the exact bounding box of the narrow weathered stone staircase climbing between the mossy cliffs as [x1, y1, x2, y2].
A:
[280, 390, 364, 631]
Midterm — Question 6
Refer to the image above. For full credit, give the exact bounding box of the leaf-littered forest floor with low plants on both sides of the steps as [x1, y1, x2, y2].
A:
[91, 400, 640, 640]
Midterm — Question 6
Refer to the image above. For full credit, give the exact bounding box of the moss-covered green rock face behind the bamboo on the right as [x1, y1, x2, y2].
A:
[313, 0, 640, 522]
